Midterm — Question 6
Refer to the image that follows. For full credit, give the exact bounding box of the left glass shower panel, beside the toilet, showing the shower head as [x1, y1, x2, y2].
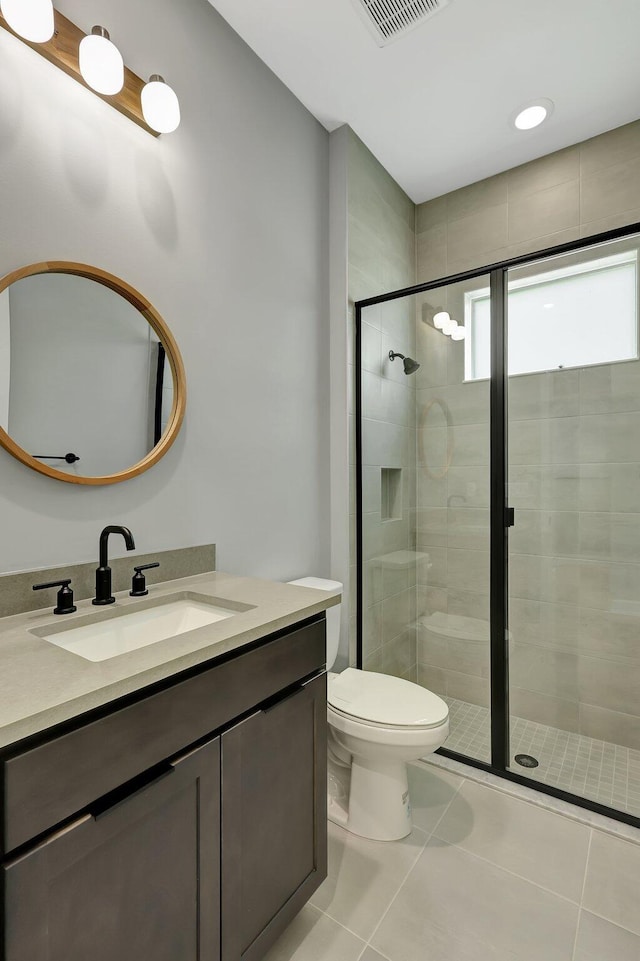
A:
[359, 275, 491, 762]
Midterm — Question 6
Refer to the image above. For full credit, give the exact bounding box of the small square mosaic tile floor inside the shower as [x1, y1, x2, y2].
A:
[445, 697, 640, 817]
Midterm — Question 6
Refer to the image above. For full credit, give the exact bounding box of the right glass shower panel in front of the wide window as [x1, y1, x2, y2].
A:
[507, 235, 640, 816]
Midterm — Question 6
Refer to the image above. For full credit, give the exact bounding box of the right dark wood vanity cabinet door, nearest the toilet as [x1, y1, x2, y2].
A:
[221, 674, 327, 961]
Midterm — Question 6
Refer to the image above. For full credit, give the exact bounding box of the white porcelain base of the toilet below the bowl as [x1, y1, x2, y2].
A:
[328, 757, 412, 841]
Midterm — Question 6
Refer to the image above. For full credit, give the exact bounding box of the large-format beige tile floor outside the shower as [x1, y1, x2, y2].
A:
[265, 762, 640, 961]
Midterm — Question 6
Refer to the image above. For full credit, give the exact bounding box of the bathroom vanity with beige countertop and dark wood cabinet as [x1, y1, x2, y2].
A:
[0, 574, 339, 961]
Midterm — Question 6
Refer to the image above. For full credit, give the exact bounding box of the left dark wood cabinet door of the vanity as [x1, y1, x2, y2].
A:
[3, 739, 220, 961]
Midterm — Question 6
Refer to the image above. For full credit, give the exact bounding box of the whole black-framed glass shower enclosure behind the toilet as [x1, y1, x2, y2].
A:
[356, 219, 640, 826]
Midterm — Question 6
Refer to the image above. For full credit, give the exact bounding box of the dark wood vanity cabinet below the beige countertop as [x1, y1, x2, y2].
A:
[1, 618, 326, 961]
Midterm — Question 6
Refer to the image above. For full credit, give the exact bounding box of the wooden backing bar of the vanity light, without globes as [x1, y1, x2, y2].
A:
[0, 10, 159, 137]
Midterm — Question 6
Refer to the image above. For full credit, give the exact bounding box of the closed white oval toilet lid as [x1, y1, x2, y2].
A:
[328, 667, 449, 727]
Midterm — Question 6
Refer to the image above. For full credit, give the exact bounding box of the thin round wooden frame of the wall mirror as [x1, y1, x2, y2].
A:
[0, 260, 187, 486]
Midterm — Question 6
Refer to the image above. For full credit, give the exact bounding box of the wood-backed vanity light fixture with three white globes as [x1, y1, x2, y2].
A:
[0, 6, 180, 137]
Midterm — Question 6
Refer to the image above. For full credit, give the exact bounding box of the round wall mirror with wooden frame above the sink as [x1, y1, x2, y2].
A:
[0, 261, 186, 484]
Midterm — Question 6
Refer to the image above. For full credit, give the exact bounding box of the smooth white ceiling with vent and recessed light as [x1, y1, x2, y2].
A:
[209, 0, 640, 203]
